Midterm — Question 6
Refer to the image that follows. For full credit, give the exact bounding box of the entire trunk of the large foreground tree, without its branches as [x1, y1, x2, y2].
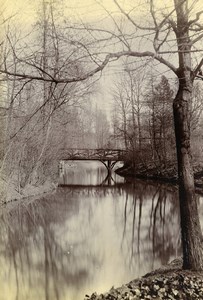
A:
[173, 0, 203, 270]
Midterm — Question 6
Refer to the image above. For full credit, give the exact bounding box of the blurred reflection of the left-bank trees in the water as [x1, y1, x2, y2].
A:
[0, 194, 99, 300]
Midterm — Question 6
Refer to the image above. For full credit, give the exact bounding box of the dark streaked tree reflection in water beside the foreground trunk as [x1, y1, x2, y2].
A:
[118, 180, 181, 271]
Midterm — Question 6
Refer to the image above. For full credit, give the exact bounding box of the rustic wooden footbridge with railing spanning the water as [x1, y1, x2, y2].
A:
[60, 148, 128, 173]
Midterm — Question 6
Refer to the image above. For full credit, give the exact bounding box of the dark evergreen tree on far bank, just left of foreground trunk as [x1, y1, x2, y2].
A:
[147, 75, 175, 163]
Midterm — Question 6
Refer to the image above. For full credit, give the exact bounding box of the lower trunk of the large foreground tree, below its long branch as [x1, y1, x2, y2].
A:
[173, 79, 203, 270]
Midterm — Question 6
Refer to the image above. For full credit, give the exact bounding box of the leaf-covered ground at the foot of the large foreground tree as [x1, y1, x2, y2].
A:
[85, 259, 203, 300]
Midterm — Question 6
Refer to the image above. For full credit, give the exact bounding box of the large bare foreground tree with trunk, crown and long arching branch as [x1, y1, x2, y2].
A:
[79, 0, 203, 270]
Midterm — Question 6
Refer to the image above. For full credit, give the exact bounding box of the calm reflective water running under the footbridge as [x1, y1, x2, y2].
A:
[0, 162, 203, 300]
